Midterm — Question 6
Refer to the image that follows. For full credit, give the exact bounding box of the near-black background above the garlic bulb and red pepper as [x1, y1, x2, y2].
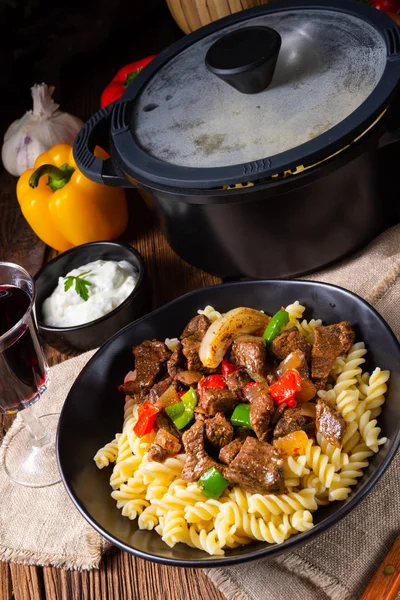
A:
[0, 0, 183, 140]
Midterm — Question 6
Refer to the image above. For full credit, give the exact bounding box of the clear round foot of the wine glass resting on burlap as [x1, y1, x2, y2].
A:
[3, 413, 61, 487]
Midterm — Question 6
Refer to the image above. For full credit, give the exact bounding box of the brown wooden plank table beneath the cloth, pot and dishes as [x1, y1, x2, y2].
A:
[0, 163, 228, 600]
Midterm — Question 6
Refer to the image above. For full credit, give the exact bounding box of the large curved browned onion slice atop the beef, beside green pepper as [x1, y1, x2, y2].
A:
[199, 307, 270, 369]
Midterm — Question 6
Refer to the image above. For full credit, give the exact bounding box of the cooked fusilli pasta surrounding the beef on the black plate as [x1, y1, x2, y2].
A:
[94, 301, 390, 555]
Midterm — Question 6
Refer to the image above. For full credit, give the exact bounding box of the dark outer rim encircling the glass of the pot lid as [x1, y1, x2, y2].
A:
[110, 0, 400, 190]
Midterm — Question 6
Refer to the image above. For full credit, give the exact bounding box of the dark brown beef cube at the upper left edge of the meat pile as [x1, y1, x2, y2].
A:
[133, 340, 171, 387]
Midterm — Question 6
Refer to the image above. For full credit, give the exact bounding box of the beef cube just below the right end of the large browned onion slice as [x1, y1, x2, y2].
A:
[232, 335, 268, 381]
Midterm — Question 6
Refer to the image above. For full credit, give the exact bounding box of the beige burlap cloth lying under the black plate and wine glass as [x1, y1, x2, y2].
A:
[0, 225, 400, 600]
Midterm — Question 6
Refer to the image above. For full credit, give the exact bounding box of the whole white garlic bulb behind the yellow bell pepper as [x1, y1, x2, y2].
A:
[1, 83, 83, 176]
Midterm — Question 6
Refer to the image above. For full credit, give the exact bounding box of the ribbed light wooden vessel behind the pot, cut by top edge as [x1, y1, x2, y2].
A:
[167, 0, 270, 33]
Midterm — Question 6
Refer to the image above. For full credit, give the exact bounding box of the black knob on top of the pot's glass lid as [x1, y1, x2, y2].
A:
[205, 27, 281, 94]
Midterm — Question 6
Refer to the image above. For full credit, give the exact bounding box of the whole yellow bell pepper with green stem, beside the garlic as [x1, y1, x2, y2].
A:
[17, 144, 128, 252]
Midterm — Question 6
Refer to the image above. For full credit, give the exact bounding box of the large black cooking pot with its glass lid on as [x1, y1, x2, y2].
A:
[74, 0, 400, 278]
